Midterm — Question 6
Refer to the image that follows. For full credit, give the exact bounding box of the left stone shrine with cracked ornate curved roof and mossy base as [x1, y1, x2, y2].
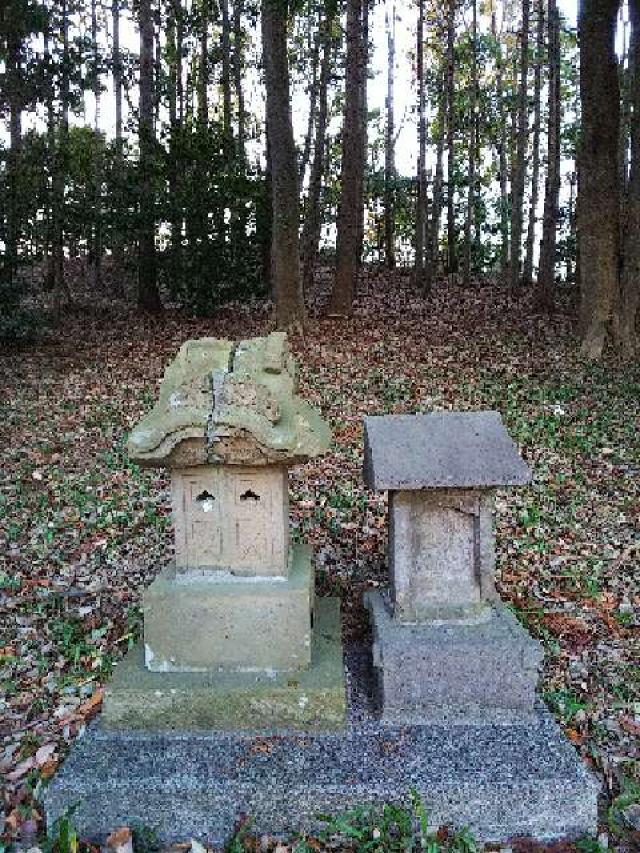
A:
[103, 333, 345, 729]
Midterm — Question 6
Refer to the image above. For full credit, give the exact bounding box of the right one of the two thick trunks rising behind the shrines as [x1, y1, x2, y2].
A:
[330, 0, 367, 315]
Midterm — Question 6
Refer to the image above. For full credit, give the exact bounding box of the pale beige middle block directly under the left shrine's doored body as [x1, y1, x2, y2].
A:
[143, 545, 314, 672]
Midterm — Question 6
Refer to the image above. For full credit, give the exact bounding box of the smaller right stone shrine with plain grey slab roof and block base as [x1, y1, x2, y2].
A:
[365, 412, 542, 723]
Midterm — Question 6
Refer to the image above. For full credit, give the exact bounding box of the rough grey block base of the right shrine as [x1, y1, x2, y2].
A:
[365, 592, 542, 726]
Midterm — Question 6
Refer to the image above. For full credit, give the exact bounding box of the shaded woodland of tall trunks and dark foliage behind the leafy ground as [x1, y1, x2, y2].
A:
[0, 0, 640, 358]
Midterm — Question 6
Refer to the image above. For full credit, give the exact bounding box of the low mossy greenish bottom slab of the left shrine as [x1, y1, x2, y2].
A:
[102, 598, 346, 732]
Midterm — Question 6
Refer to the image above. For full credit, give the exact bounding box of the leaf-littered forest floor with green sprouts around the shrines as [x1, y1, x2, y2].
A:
[0, 270, 640, 850]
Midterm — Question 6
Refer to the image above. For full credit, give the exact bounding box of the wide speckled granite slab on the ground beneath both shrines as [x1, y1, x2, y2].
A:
[45, 649, 599, 845]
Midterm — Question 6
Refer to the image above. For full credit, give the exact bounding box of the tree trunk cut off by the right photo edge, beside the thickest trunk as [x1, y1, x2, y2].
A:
[613, 0, 640, 358]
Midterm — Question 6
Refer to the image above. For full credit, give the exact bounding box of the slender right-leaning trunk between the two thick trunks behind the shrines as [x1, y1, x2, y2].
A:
[302, 5, 333, 291]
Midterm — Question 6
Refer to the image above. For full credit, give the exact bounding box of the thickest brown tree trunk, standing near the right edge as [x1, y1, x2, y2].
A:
[578, 0, 620, 359]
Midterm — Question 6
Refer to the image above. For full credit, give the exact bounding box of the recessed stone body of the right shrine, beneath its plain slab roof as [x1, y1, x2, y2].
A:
[389, 489, 496, 622]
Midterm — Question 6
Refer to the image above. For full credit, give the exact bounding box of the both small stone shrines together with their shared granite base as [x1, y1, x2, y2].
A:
[44, 346, 599, 845]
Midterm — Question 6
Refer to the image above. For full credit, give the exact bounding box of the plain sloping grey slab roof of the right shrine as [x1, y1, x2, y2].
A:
[364, 411, 531, 491]
